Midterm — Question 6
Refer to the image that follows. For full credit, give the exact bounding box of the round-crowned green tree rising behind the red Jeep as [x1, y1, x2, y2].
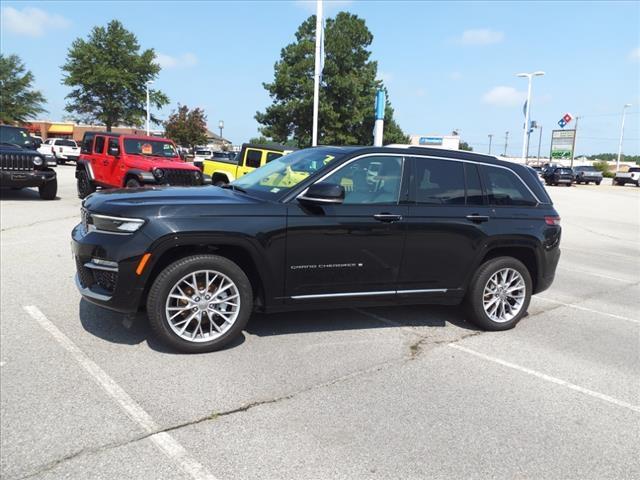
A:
[62, 20, 169, 131]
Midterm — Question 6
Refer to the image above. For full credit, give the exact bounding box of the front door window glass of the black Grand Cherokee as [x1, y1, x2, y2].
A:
[323, 157, 403, 205]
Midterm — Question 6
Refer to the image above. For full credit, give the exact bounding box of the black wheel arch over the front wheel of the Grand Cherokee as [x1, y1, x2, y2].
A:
[142, 232, 283, 306]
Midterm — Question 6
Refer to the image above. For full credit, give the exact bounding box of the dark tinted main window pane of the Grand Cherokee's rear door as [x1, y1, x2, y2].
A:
[414, 157, 464, 205]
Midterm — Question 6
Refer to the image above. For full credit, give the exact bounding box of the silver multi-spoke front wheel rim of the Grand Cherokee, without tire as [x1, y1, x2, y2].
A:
[165, 270, 240, 343]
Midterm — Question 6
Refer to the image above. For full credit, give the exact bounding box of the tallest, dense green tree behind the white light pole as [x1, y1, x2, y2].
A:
[255, 12, 408, 147]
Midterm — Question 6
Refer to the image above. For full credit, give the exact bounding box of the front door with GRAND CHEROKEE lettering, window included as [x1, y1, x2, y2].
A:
[285, 155, 408, 301]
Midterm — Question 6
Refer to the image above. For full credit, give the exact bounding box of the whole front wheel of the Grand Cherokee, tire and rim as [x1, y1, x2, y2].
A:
[147, 255, 253, 353]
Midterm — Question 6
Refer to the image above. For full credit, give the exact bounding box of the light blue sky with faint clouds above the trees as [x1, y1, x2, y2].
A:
[0, 1, 640, 155]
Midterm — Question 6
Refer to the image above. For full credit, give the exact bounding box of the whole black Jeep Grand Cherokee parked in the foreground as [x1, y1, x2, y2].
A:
[72, 147, 560, 352]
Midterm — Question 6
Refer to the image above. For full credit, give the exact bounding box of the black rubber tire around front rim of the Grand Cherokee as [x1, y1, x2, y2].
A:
[147, 255, 253, 353]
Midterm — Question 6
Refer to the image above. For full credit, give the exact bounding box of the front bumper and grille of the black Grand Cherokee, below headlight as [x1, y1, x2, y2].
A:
[71, 224, 149, 313]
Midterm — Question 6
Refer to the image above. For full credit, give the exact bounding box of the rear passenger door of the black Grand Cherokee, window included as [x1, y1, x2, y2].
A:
[398, 157, 491, 299]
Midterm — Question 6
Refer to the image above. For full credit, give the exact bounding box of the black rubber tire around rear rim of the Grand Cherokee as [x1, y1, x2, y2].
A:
[464, 257, 533, 331]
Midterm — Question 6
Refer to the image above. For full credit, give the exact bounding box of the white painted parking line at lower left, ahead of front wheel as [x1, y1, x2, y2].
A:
[23, 306, 216, 480]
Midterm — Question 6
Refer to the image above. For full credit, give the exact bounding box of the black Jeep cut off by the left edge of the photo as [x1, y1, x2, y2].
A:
[0, 125, 58, 200]
